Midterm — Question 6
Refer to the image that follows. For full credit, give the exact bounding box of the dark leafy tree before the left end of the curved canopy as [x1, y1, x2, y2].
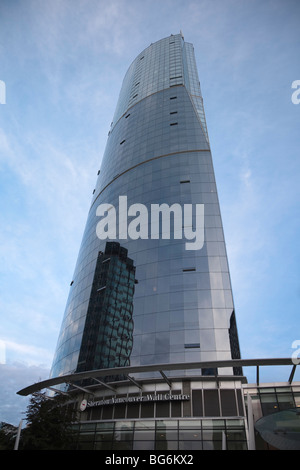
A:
[20, 393, 75, 450]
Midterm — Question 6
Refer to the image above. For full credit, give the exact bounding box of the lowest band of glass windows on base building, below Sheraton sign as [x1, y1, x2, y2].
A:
[76, 419, 247, 451]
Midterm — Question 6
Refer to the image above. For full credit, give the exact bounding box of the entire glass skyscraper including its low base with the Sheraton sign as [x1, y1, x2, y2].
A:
[18, 34, 300, 452]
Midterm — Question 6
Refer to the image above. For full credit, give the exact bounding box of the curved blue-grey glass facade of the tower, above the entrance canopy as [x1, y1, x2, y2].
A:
[51, 34, 239, 377]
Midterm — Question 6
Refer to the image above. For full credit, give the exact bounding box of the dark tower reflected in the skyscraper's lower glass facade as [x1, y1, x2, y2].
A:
[76, 242, 135, 372]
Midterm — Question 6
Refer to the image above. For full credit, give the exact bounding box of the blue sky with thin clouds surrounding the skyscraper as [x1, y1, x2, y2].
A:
[0, 0, 300, 424]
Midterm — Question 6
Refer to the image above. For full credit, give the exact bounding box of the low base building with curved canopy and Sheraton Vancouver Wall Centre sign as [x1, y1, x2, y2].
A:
[18, 359, 300, 451]
